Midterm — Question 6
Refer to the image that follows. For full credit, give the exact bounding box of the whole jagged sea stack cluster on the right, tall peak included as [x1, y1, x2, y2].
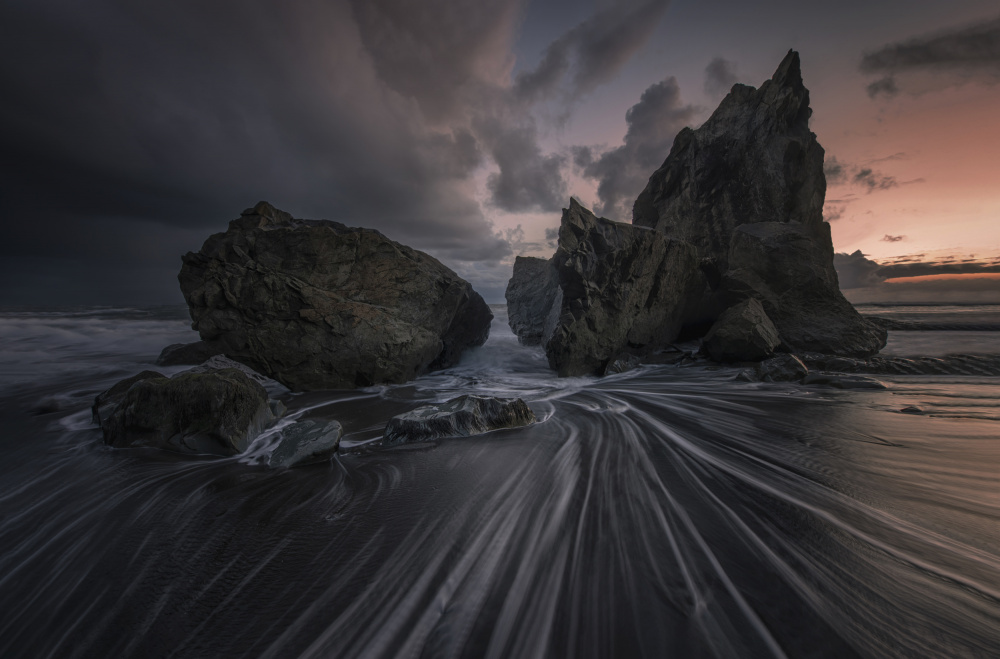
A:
[506, 51, 886, 375]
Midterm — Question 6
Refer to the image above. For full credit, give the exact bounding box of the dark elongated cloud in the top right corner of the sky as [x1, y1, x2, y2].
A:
[860, 18, 1000, 98]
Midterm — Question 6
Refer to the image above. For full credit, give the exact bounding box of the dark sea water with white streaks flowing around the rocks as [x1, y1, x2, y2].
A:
[0, 306, 1000, 657]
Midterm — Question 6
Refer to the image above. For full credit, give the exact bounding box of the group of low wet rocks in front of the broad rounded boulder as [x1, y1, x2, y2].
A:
[91, 356, 536, 468]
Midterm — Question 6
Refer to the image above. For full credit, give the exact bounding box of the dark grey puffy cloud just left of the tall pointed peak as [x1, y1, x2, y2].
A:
[573, 77, 699, 220]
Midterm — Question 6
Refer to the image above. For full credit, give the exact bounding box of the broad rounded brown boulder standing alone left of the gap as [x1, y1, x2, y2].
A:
[178, 202, 493, 391]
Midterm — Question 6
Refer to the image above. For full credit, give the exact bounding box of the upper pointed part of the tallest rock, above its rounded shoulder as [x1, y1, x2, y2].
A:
[632, 51, 833, 270]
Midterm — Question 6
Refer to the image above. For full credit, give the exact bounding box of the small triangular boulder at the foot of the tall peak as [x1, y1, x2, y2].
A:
[702, 298, 781, 362]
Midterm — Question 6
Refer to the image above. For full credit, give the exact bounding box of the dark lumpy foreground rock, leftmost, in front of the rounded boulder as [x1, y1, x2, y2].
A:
[93, 369, 275, 455]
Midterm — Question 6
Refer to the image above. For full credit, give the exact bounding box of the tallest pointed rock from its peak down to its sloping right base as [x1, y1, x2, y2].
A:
[633, 51, 886, 356]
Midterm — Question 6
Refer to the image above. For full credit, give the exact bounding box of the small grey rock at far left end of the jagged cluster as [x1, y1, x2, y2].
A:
[504, 256, 559, 345]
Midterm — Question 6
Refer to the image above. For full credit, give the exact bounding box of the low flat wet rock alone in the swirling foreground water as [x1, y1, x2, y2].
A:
[382, 395, 536, 446]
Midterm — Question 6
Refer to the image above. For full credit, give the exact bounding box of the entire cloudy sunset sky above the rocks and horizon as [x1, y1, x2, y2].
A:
[0, 0, 1000, 305]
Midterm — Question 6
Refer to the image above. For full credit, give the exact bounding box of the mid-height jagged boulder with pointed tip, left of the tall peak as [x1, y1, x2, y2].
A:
[544, 199, 704, 376]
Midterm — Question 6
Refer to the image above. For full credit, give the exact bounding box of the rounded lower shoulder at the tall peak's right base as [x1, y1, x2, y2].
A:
[722, 222, 887, 357]
